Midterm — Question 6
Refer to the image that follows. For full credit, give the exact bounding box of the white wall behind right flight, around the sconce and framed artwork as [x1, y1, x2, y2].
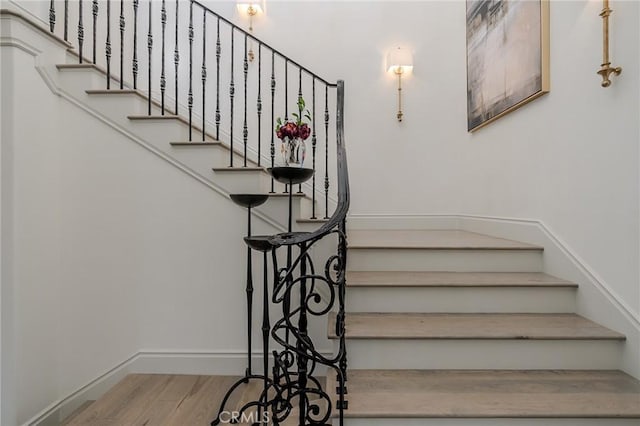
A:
[236, 1, 640, 317]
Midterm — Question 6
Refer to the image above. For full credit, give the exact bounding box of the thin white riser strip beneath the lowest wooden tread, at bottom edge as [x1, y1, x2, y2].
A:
[333, 418, 638, 426]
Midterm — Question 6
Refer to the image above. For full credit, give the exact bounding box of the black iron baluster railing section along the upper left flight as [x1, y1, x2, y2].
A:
[49, 0, 337, 219]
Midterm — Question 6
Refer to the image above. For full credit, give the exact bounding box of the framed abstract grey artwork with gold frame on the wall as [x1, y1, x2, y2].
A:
[467, 0, 549, 132]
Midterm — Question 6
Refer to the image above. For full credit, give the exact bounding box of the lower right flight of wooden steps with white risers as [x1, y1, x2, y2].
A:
[327, 230, 640, 426]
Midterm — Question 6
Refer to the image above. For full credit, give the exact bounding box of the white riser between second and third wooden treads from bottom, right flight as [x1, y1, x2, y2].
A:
[347, 287, 575, 313]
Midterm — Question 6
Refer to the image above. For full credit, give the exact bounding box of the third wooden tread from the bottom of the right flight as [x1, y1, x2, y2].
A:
[347, 271, 578, 287]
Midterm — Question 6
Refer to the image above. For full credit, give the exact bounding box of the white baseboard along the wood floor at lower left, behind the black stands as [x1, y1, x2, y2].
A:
[22, 350, 332, 426]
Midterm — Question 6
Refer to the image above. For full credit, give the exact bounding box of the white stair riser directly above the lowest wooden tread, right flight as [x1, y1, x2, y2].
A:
[347, 339, 623, 370]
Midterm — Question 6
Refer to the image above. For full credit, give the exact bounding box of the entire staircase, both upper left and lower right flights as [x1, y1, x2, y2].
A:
[5, 3, 640, 426]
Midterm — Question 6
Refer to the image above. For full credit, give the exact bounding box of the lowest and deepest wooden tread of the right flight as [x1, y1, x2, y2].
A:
[327, 370, 640, 418]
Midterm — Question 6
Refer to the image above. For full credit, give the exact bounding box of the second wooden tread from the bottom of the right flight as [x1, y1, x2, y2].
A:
[329, 313, 625, 340]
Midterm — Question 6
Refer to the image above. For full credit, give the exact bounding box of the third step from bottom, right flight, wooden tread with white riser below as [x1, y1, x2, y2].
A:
[346, 271, 578, 313]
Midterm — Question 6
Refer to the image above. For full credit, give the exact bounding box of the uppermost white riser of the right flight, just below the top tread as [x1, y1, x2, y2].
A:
[347, 248, 542, 272]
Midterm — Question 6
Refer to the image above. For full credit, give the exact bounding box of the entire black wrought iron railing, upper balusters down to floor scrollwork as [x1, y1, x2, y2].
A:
[49, 0, 349, 425]
